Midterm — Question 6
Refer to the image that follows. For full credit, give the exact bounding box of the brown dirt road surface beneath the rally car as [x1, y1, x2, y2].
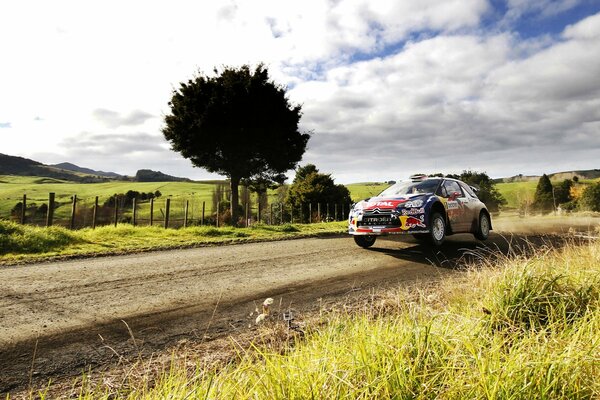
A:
[0, 219, 592, 393]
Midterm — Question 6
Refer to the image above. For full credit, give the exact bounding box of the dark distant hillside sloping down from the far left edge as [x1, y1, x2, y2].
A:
[0, 154, 107, 183]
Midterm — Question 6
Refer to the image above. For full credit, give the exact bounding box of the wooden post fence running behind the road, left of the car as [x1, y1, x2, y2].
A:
[4, 193, 351, 229]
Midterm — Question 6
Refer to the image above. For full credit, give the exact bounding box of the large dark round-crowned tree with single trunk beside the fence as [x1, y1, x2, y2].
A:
[162, 65, 310, 223]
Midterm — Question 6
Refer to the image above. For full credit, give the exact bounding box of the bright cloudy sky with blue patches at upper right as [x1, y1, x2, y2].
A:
[0, 0, 600, 183]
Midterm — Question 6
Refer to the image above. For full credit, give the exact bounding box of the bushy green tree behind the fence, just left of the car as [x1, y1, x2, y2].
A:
[286, 164, 352, 223]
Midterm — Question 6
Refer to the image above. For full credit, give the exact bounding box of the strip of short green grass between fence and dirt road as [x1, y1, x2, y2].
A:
[0, 220, 347, 265]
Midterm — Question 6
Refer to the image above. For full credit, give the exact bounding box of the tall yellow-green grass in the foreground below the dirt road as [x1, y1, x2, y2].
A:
[35, 241, 600, 399]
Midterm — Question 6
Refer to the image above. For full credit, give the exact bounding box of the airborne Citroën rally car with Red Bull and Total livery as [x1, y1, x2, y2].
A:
[348, 175, 492, 248]
